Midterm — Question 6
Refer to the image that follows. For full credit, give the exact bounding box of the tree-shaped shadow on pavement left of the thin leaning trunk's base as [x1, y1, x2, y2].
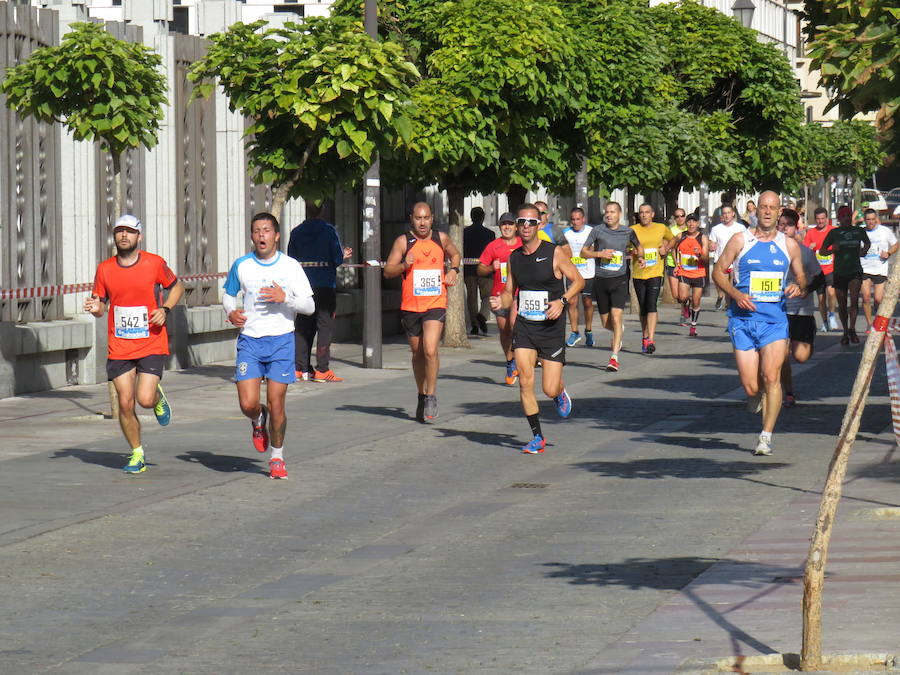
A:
[545, 556, 801, 656]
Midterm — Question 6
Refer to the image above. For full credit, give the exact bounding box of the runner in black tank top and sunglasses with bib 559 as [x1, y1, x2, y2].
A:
[491, 204, 584, 454]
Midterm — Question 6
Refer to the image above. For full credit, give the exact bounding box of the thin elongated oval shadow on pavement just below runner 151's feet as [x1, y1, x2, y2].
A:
[572, 457, 790, 480]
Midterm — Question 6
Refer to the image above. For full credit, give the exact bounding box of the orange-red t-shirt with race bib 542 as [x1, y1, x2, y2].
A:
[92, 251, 178, 360]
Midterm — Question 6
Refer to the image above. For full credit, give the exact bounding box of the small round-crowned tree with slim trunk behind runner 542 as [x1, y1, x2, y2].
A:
[0, 23, 166, 216]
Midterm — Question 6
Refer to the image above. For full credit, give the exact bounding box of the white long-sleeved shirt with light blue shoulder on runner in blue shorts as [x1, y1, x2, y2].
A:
[222, 251, 316, 337]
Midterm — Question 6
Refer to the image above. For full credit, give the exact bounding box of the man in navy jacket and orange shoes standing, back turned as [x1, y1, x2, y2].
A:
[288, 202, 353, 382]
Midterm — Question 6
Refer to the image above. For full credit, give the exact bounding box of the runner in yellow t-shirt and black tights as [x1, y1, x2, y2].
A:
[631, 202, 675, 354]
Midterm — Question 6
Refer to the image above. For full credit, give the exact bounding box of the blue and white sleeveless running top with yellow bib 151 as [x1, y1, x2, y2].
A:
[728, 230, 791, 323]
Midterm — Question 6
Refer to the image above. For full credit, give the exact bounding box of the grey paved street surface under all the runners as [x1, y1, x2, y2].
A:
[0, 308, 900, 675]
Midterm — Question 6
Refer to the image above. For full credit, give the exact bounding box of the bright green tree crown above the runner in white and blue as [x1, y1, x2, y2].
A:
[189, 17, 418, 217]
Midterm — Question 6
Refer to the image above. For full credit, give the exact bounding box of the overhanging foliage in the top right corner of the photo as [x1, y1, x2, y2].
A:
[805, 0, 900, 161]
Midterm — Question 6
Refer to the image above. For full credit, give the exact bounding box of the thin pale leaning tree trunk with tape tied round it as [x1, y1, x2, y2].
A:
[800, 258, 900, 671]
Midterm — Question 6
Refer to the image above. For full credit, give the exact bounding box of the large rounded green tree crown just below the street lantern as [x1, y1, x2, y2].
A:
[589, 0, 806, 213]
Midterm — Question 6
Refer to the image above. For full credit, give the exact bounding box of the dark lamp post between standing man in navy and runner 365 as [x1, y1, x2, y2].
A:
[362, 0, 381, 368]
